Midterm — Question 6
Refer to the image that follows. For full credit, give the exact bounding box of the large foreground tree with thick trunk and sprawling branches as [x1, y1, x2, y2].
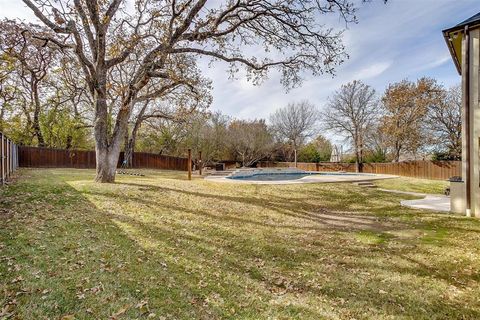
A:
[23, 0, 355, 182]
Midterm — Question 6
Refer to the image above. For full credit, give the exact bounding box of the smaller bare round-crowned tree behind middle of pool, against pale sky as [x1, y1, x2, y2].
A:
[270, 101, 318, 166]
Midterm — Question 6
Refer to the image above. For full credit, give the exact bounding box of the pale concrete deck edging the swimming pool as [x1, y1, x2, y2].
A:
[204, 172, 398, 184]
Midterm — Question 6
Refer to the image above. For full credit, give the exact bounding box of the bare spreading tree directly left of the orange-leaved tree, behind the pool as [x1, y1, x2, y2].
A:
[323, 80, 378, 172]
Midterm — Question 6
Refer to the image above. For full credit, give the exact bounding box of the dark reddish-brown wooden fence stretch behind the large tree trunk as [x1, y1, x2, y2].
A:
[18, 146, 188, 171]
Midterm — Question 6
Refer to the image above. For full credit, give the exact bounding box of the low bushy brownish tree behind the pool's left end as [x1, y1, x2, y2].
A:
[228, 120, 273, 167]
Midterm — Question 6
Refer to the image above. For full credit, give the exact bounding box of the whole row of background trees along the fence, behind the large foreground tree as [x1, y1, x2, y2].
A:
[0, 20, 461, 170]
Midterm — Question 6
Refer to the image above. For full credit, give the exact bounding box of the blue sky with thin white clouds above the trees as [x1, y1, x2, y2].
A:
[0, 0, 480, 124]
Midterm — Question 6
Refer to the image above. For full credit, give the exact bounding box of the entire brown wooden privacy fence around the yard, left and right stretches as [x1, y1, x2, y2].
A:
[15, 146, 462, 179]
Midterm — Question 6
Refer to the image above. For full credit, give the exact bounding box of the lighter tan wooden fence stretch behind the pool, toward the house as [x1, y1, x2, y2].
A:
[258, 161, 462, 180]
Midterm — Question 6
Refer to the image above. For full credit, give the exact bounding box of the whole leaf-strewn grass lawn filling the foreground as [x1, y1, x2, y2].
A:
[0, 169, 480, 319]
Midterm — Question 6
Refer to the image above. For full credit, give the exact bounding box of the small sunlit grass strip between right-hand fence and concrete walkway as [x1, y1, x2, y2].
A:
[375, 177, 450, 194]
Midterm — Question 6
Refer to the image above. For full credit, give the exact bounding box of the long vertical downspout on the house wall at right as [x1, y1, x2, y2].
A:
[464, 26, 472, 217]
